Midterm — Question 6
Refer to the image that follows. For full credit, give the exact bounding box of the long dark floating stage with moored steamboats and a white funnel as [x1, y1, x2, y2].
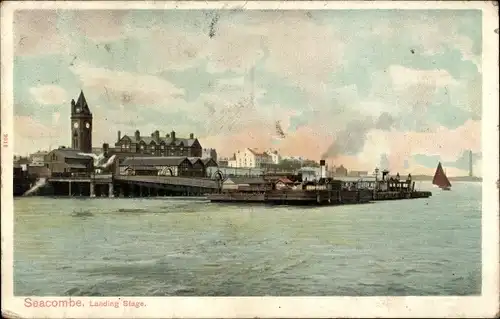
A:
[207, 160, 432, 205]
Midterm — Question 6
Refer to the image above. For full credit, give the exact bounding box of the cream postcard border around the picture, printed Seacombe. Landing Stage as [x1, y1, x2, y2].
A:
[1, 1, 499, 318]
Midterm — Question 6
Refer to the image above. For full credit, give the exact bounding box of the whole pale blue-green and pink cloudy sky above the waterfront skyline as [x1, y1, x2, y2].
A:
[14, 10, 482, 176]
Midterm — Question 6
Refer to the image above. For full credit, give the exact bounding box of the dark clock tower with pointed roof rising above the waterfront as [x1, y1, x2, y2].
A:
[71, 91, 92, 153]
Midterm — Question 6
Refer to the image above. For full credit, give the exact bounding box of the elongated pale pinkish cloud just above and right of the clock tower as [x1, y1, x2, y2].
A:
[70, 63, 184, 107]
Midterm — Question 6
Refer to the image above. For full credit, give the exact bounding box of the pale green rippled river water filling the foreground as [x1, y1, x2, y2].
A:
[14, 182, 481, 296]
